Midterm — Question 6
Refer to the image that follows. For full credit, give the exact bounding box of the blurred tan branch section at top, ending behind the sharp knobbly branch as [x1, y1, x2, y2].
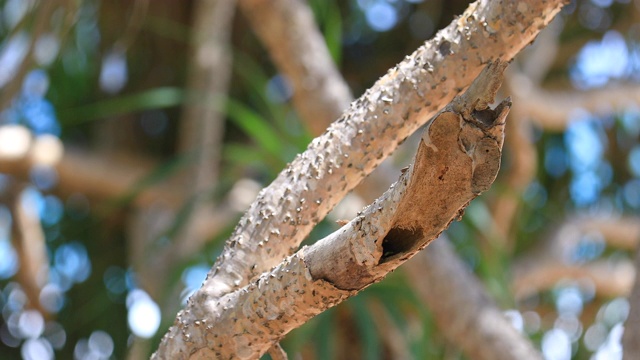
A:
[239, 0, 353, 135]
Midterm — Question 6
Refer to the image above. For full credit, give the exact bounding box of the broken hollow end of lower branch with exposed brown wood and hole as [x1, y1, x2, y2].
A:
[304, 61, 511, 290]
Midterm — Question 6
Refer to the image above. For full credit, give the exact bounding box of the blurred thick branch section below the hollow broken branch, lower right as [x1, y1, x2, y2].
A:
[406, 239, 542, 360]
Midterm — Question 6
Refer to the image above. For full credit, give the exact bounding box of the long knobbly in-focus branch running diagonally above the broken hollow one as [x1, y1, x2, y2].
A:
[202, 0, 566, 304]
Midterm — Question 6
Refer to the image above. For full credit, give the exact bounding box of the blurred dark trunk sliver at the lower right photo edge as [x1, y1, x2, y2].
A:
[622, 247, 640, 360]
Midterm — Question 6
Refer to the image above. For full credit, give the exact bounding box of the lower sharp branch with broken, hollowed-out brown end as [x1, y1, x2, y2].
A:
[153, 60, 511, 359]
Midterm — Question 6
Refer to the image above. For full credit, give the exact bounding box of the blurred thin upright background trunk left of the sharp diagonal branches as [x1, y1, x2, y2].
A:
[132, 0, 235, 300]
